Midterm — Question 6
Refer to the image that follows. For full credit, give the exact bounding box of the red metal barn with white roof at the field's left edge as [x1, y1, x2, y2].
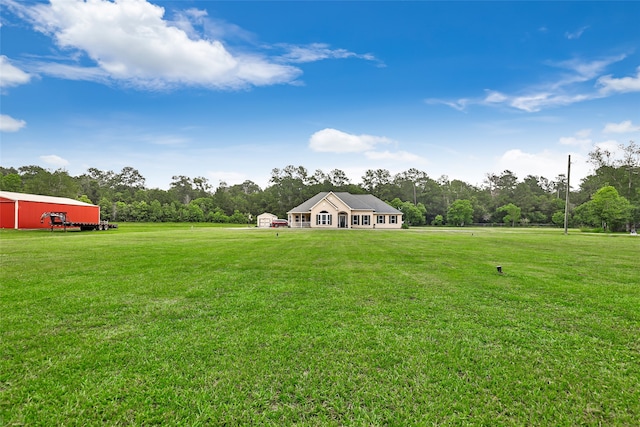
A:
[0, 191, 100, 230]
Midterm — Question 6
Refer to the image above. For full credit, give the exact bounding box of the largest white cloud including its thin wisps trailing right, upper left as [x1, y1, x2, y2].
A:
[6, 0, 384, 90]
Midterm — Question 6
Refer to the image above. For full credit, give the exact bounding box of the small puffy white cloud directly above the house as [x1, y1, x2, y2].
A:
[309, 128, 393, 153]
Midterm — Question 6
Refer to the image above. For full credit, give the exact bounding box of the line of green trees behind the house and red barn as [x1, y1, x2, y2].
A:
[0, 141, 640, 230]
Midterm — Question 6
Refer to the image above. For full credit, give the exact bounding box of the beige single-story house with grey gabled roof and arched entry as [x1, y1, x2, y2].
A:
[287, 191, 402, 229]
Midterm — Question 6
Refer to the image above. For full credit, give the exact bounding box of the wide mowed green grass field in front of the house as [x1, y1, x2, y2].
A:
[0, 224, 640, 426]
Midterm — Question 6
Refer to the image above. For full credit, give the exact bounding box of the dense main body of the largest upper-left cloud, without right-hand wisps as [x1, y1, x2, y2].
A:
[8, 0, 301, 89]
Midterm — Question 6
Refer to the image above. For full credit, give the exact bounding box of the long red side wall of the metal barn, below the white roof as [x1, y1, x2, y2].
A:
[18, 201, 100, 228]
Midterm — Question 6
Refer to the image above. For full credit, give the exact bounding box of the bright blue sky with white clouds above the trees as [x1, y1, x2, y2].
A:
[0, 0, 640, 189]
